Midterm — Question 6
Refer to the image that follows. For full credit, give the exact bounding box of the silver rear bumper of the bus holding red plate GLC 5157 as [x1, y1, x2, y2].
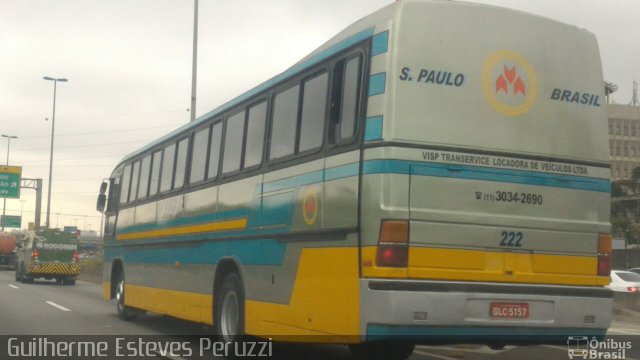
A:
[360, 279, 613, 345]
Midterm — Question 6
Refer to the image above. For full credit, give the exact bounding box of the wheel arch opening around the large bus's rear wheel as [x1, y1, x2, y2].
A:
[212, 258, 245, 342]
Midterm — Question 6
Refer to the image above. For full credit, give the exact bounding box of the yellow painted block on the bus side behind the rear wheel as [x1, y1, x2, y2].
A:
[245, 245, 359, 342]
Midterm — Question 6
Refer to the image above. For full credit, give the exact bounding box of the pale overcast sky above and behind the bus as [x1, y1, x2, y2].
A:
[0, 0, 640, 235]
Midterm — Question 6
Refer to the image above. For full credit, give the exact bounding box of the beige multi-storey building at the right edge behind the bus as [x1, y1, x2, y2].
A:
[607, 104, 640, 181]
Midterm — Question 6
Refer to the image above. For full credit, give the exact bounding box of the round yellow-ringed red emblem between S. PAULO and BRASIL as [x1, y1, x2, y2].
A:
[482, 50, 538, 116]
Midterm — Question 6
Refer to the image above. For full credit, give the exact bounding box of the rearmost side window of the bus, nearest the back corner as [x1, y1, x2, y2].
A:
[340, 56, 361, 140]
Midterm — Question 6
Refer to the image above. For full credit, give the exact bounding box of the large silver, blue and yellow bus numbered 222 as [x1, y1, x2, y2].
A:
[98, 0, 612, 359]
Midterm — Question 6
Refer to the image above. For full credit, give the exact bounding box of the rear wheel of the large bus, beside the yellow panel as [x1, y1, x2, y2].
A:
[215, 273, 244, 342]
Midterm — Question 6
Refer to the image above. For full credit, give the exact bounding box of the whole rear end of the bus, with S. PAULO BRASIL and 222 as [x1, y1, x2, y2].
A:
[360, 1, 612, 344]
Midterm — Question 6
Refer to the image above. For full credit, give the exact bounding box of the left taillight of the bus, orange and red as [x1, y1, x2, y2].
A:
[376, 220, 409, 267]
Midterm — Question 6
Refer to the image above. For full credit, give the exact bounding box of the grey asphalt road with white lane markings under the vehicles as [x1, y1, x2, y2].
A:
[0, 271, 640, 360]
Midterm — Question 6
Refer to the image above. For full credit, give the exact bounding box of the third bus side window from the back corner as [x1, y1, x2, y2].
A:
[269, 85, 300, 159]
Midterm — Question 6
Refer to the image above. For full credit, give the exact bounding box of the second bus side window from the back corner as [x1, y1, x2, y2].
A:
[298, 73, 329, 152]
